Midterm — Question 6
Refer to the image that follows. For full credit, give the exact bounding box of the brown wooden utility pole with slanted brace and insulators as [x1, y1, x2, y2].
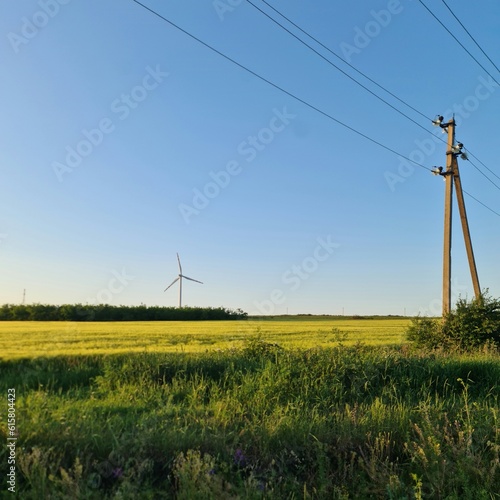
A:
[441, 118, 481, 317]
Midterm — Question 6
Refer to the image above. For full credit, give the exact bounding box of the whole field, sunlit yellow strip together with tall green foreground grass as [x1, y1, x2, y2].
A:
[0, 318, 500, 500]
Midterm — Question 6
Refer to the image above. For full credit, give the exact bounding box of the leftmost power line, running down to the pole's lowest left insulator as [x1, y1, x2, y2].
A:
[132, 0, 432, 171]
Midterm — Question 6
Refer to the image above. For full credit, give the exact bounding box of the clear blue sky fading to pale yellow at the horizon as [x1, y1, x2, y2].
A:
[0, 0, 500, 315]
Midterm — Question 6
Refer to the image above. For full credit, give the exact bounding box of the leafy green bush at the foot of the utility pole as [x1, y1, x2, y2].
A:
[406, 294, 500, 350]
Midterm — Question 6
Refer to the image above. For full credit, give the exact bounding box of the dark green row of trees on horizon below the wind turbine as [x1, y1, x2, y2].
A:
[0, 304, 247, 321]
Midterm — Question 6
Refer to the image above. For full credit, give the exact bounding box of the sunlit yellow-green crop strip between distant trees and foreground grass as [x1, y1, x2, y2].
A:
[0, 316, 410, 359]
